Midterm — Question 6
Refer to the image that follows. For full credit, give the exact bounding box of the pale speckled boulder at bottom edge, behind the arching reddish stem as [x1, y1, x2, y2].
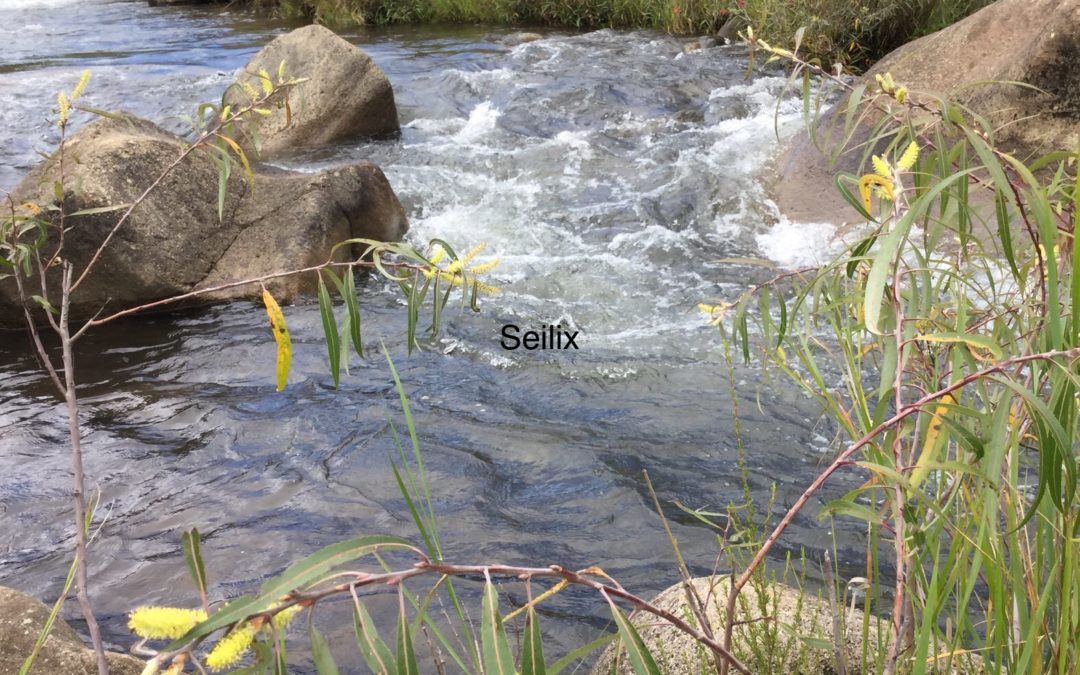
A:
[592, 577, 878, 675]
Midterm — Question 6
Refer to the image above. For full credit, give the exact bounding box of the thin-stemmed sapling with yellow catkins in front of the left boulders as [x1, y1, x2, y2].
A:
[0, 69, 498, 675]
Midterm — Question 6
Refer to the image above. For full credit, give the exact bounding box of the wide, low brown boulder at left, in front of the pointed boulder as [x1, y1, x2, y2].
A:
[0, 116, 407, 325]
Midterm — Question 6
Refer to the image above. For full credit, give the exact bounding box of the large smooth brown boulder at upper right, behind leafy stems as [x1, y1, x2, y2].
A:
[775, 0, 1080, 222]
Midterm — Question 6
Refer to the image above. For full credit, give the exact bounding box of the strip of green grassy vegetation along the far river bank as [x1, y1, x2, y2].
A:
[247, 0, 991, 68]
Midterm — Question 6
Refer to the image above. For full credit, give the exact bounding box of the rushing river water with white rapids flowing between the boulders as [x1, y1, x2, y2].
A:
[0, 0, 860, 667]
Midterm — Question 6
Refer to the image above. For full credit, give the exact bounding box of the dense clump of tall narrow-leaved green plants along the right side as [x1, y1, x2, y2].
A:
[704, 32, 1080, 675]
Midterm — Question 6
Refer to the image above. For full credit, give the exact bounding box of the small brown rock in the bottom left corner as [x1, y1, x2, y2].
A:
[0, 586, 146, 675]
